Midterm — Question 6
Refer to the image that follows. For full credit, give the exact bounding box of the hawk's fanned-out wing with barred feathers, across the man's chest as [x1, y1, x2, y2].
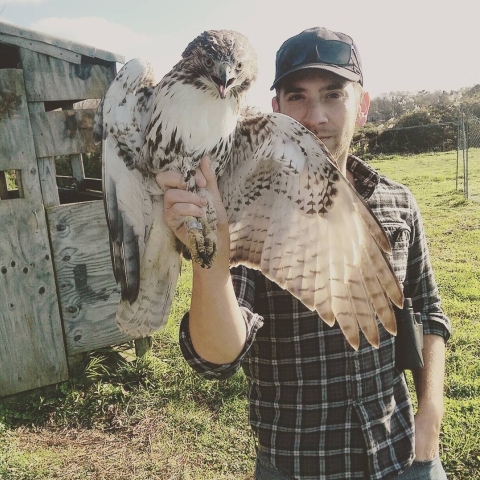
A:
[219, 114, 403, 348]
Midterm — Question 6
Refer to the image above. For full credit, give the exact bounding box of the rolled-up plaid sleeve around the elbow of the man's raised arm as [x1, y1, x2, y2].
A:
[179, 266, 263, 380]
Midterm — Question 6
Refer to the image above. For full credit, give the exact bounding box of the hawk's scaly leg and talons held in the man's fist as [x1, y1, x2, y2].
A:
[185, 168, 217, 268]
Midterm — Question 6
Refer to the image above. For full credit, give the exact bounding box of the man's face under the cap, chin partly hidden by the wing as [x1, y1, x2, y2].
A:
[272, 69, 369, 170]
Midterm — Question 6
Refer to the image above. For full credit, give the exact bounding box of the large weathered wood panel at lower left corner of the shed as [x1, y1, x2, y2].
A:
[0, 199, 68, 396]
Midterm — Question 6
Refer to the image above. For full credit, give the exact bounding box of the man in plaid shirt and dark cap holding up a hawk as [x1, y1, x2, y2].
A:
[157, 28, 450, 480]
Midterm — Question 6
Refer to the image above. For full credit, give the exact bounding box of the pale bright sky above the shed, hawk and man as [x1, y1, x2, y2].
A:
[0, 0, 480, 111]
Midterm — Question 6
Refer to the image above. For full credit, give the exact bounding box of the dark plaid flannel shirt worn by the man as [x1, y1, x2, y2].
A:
[180, 156, 450, 480]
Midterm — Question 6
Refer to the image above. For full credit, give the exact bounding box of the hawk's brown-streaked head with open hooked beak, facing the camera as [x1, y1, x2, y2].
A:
[181, 30, 257, 98]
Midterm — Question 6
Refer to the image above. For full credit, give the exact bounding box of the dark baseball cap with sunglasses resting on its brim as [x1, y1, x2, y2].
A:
[270, 27, 363, 90]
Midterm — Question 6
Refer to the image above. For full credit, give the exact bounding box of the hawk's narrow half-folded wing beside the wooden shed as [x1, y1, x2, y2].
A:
[94, 59, 154, 301]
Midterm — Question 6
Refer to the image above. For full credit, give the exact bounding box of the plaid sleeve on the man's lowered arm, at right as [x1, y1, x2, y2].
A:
[404, 191, 451, 342]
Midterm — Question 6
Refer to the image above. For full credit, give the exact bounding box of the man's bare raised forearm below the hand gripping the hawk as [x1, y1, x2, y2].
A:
[189, 227, 246, 364]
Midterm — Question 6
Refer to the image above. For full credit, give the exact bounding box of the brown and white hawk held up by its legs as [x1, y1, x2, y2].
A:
[94, 30, 403, 349]
